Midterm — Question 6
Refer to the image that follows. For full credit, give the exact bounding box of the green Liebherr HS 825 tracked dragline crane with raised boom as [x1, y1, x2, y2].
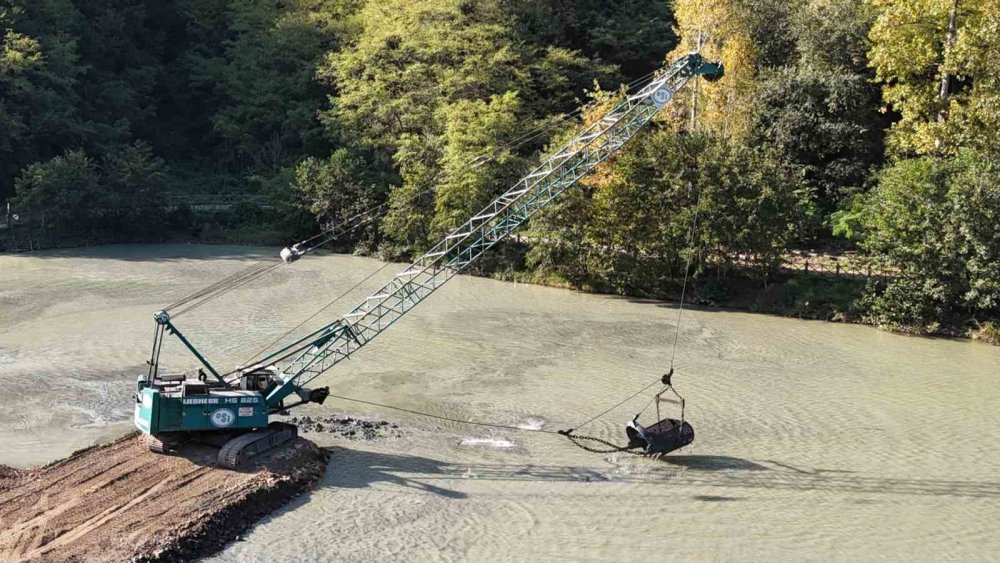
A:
[134, 53, 723, 467]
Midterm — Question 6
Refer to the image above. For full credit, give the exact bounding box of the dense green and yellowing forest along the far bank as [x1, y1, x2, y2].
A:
[0, 0, 1000, 340]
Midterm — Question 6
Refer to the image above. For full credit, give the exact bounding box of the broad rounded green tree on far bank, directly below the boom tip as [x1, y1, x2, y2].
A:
[528, 128, 810, 294]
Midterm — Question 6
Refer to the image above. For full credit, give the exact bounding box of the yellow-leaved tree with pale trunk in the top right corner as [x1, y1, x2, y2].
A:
[869, 0, 1000, 156]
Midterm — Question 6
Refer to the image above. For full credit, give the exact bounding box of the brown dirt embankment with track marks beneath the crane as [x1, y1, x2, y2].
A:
[0, 434, 326, 561]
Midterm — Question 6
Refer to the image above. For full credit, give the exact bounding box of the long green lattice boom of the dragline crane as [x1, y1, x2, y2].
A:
[268, 54, 714, 403]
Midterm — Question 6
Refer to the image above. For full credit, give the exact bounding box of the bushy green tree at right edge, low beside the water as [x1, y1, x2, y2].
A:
[863, 150, 1000, 332]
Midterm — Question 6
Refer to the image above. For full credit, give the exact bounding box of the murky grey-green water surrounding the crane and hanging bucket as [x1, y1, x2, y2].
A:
[0, 245, 1000, 562]
